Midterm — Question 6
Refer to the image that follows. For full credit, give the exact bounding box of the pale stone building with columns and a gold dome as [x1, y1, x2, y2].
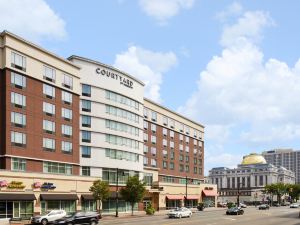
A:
[209, 153, 295, 203]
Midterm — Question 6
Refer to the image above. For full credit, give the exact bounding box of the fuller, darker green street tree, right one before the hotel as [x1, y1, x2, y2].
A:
[120, 176, 146, 216]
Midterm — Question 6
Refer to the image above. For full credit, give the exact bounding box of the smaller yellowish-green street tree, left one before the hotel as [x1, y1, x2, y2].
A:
[90, 180, 110, 217]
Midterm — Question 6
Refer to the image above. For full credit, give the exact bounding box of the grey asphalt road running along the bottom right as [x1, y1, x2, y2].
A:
[99, 207, 300, 225]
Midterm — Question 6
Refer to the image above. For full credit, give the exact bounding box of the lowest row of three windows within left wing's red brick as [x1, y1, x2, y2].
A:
[11, 131, 72, 153]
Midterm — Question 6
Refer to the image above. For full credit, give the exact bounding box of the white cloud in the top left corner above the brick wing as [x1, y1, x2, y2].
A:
[0, 0, 66, 42]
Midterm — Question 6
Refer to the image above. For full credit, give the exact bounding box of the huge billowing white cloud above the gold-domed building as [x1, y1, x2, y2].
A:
[178, 7, 300, 155]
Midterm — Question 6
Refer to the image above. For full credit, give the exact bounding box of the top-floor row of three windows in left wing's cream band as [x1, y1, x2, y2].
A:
[11, 52, 73, 89]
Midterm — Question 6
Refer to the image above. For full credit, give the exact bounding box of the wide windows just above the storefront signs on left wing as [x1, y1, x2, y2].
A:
[11, 158, 73, 175]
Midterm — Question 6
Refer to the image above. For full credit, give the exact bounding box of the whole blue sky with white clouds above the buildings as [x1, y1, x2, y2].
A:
[0, 0, 300, 175]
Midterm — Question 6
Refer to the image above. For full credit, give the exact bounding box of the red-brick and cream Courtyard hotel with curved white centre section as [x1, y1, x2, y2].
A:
[0, 31, 216, 219]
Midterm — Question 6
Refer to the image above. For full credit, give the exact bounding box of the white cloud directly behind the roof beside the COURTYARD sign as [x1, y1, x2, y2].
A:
[114, 46, 177, 102]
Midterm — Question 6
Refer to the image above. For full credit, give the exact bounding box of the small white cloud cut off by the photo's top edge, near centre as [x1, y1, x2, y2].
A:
[139, 0, 194, 25]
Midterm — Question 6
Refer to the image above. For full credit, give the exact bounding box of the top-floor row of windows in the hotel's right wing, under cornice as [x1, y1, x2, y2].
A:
[144, 108, 202, 139]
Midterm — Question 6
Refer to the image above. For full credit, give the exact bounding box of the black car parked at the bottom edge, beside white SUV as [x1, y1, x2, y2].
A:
[54, 212, 100, 225]
